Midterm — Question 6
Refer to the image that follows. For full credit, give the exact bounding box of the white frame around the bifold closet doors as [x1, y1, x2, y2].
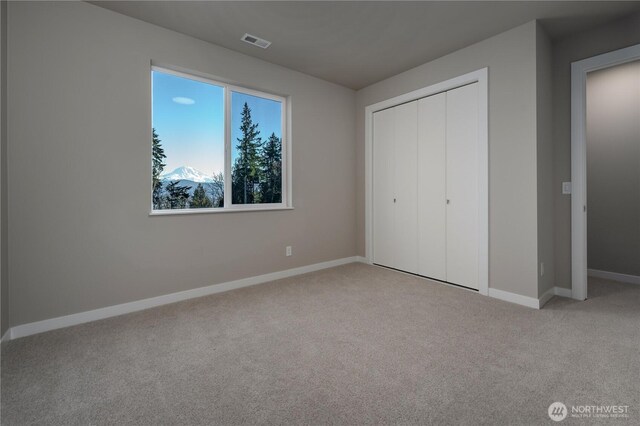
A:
[364, 68, 489, 295]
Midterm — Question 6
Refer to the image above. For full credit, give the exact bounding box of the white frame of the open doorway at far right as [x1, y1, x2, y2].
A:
[571, 44, 640, 300]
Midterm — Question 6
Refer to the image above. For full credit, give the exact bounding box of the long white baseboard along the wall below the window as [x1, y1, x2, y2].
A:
[2, 256, 364, 341]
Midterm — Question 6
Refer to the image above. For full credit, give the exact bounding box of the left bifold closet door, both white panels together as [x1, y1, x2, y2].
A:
[373, 101, 418, 273]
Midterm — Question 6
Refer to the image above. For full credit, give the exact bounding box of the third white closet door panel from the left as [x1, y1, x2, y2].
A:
[418, 93, 447, 281]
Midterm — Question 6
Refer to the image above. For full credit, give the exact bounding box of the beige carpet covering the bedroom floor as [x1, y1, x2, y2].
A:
[1, 264, 640, 425]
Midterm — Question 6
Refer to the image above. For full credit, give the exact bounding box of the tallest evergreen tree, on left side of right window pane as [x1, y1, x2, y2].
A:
[231, 102, 262, 204]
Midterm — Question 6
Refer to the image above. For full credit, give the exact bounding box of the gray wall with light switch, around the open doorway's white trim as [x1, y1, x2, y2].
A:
[553, 14, 640, 288]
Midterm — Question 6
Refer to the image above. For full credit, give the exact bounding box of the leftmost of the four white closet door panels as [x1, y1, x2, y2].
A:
[373, 109, 395, 267]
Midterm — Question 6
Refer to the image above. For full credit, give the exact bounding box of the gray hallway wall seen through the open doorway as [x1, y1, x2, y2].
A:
[587, 61, 640, 276]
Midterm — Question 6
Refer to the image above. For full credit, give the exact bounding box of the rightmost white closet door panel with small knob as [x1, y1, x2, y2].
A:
[446, 83, 478, 289]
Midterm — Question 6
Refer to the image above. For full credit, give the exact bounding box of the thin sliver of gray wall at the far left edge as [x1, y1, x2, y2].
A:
[0, 1, 9, 336]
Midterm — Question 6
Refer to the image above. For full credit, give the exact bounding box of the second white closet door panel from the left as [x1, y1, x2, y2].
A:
[393, 101, 418, 273]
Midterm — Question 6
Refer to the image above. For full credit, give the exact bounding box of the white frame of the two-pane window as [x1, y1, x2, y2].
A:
[149, 65, 293, 216]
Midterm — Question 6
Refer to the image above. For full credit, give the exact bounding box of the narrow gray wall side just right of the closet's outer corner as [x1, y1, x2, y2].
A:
[536, 24, 555, 297]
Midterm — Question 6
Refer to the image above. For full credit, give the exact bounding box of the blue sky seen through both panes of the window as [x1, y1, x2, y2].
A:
[152, 71, 282, 174]
